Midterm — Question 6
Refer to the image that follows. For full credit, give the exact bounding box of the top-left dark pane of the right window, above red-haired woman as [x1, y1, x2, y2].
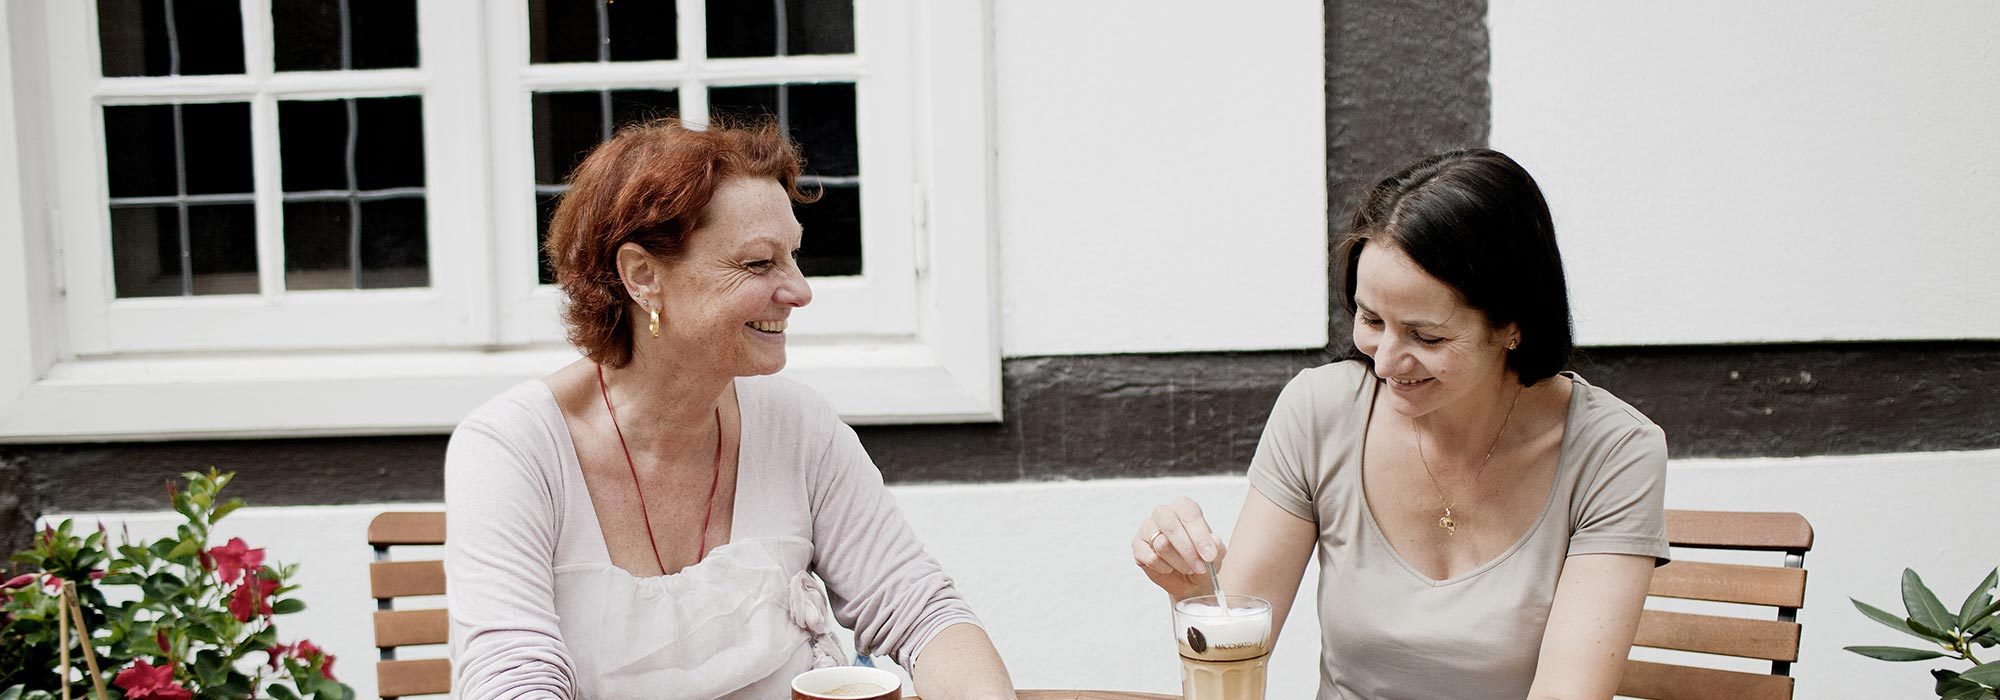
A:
[528, 0, 680, 64]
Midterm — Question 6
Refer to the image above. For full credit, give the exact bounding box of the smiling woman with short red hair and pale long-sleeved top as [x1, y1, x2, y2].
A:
[444, 120, 1014, 698]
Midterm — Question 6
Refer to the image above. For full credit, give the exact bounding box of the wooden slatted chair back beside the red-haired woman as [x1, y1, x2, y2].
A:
[368, 512, 452, 698]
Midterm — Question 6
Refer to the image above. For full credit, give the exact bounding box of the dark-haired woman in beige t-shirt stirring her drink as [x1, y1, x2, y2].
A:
[1132, 150, 1668, 700]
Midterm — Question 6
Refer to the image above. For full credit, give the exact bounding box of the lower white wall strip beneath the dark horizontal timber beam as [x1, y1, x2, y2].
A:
[52, 452, 2000, 698]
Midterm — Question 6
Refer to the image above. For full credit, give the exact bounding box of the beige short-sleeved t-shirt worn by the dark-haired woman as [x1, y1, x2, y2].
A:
[1250, 362, 1668, 700]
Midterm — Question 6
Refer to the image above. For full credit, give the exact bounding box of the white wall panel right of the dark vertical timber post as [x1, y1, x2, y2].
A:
[1488, 0, 2000, 344]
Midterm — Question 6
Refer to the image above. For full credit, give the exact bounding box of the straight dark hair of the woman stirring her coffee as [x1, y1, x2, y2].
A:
[1334, 148, 1574, 386]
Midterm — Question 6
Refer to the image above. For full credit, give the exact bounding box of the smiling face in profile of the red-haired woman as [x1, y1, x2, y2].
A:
[620, 178, 812, 376]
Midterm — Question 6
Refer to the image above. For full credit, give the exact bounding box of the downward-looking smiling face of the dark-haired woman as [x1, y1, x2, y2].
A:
[1354, 242, 1518, 418]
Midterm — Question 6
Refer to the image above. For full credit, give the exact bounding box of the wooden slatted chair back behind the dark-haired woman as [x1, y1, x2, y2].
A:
[1618, 510, 1812, 700]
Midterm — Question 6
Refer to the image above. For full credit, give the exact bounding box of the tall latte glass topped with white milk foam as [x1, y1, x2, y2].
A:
[1174, 596, 1272, 700]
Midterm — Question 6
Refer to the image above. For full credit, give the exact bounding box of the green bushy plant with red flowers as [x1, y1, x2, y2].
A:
[0, 470, 354, 700]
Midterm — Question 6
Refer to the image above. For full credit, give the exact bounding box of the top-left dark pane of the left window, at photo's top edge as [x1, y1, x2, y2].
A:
[98, 0, 244, 76]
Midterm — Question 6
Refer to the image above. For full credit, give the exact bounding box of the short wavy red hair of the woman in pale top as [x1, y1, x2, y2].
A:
[544, 118, 818, 368]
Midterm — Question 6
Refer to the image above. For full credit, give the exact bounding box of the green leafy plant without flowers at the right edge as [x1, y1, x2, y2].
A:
[1848, 568, 2000, 700]
